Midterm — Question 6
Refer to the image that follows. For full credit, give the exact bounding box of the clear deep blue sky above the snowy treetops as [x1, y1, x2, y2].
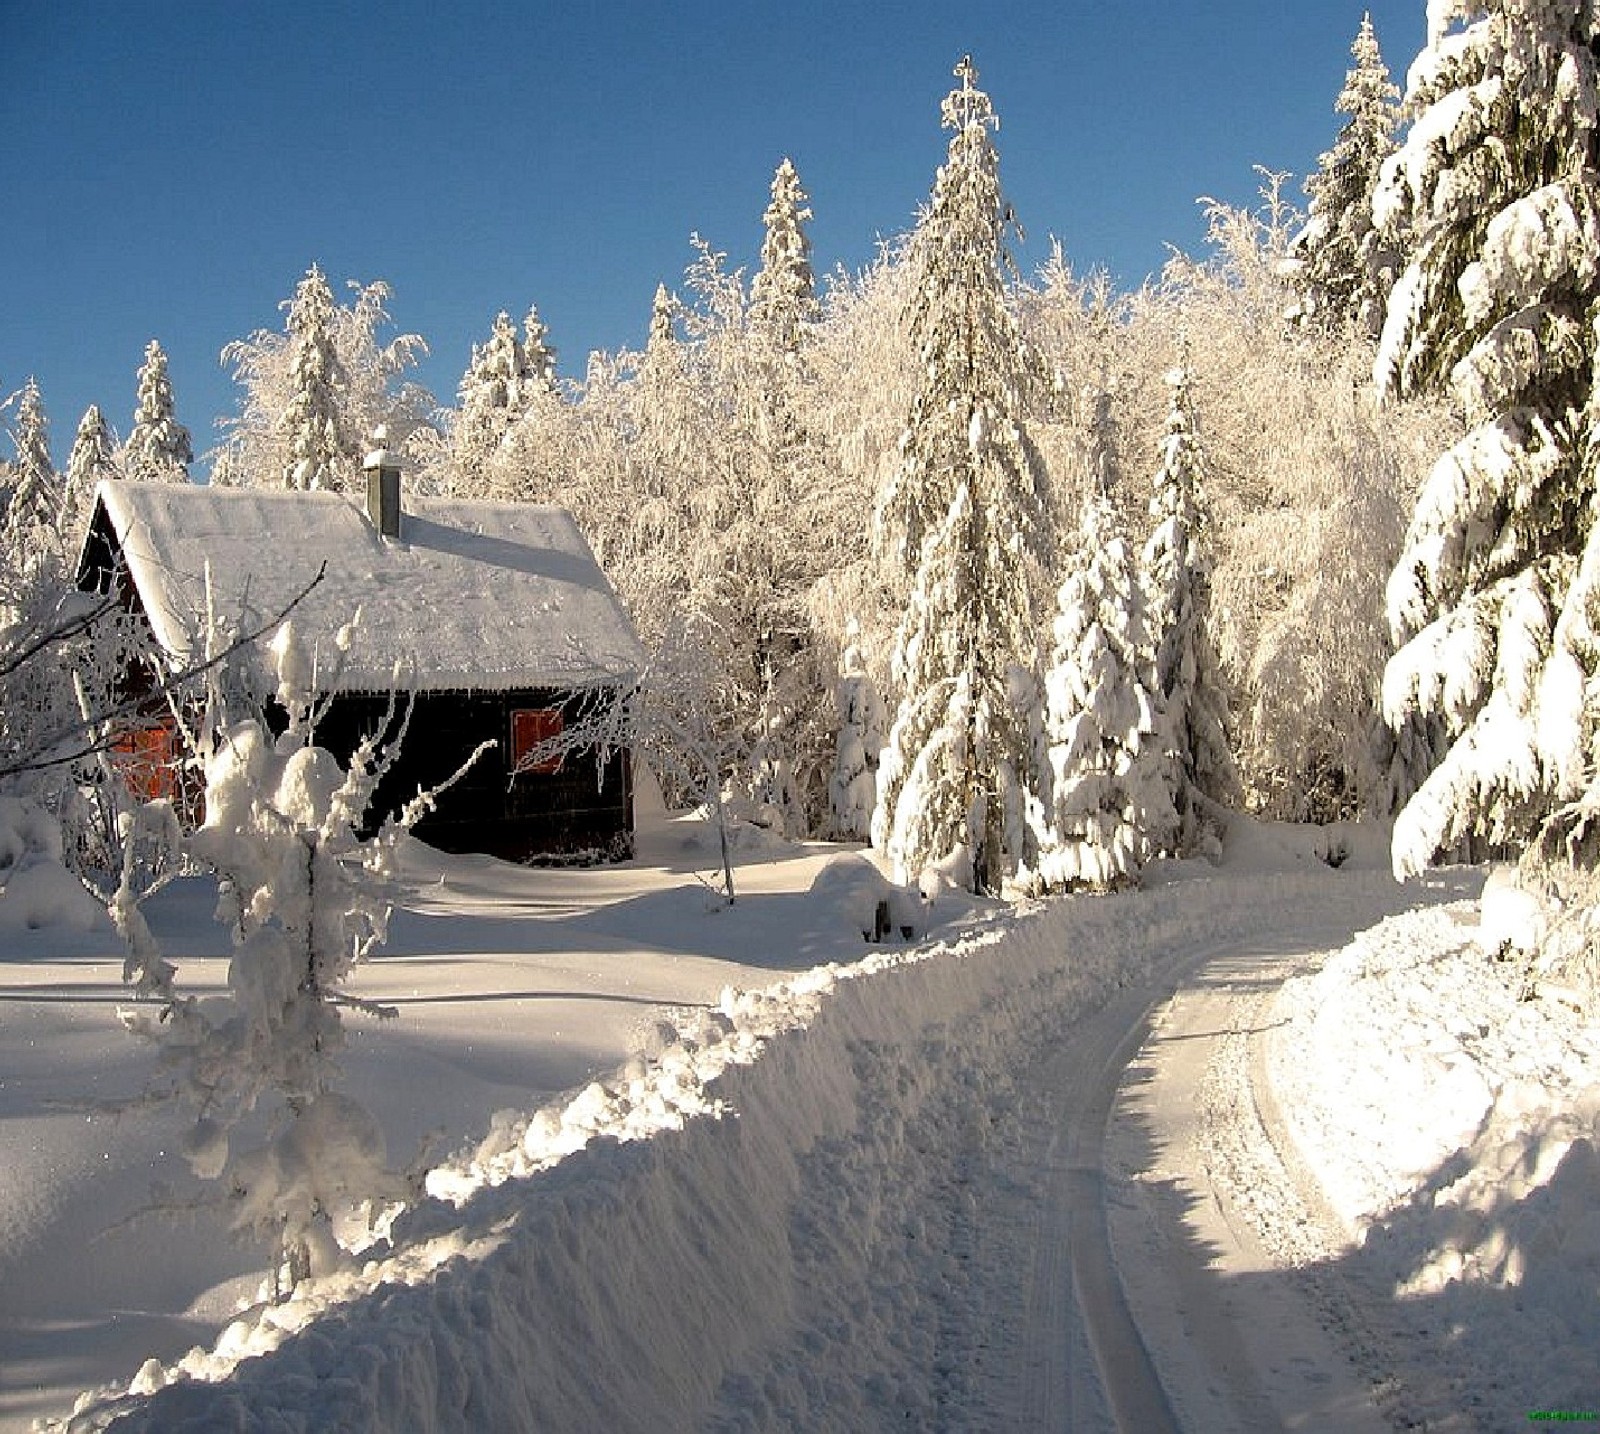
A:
[0, 0, 1424, 469]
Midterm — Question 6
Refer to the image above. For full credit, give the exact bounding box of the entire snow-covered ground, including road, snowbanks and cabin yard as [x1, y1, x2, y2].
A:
[0, 800, 1600, 1431]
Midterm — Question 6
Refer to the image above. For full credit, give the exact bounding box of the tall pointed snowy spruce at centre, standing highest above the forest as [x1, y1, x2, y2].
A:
[872, 58, 1048, 893]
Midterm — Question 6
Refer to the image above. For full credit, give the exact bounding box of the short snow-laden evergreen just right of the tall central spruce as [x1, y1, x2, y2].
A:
[1035, 477, 1178, 891]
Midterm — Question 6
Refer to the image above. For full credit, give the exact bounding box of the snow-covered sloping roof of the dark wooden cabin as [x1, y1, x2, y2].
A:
[91, 480, 645, 691]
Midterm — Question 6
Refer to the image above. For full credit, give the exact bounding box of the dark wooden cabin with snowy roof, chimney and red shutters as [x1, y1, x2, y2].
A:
[78, 469, 643, 861]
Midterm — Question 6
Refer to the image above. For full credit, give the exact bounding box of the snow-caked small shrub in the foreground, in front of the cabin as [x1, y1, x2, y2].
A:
[114, 624, 467, 1285]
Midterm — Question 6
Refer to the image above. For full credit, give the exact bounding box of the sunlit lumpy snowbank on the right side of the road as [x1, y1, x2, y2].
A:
[1269, 887, 1600, 1428]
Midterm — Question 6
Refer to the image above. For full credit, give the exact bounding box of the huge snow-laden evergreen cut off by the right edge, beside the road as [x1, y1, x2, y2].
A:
[1374, 0, 1600, 874]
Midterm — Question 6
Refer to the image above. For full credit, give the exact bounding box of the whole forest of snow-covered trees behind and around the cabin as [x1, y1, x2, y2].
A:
[0, 0, 1600, 960]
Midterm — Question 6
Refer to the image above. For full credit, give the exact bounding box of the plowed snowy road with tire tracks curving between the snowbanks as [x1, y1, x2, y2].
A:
[979, 899, 1408, 1434]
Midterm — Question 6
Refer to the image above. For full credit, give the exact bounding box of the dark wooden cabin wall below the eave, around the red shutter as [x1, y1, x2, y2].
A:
[305, 690, 634, 861]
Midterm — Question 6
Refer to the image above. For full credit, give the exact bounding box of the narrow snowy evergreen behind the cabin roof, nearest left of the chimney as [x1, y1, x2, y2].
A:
[283, 264, 350, 490]
